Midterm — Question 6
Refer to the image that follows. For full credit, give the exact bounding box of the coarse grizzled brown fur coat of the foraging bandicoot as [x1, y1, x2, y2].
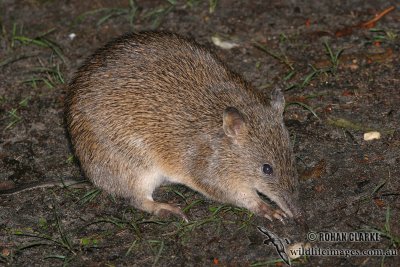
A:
[66, 32, 300, 223]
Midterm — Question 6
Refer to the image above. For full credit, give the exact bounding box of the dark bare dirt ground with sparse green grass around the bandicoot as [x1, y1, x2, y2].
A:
[0, 0, 400, 266]
